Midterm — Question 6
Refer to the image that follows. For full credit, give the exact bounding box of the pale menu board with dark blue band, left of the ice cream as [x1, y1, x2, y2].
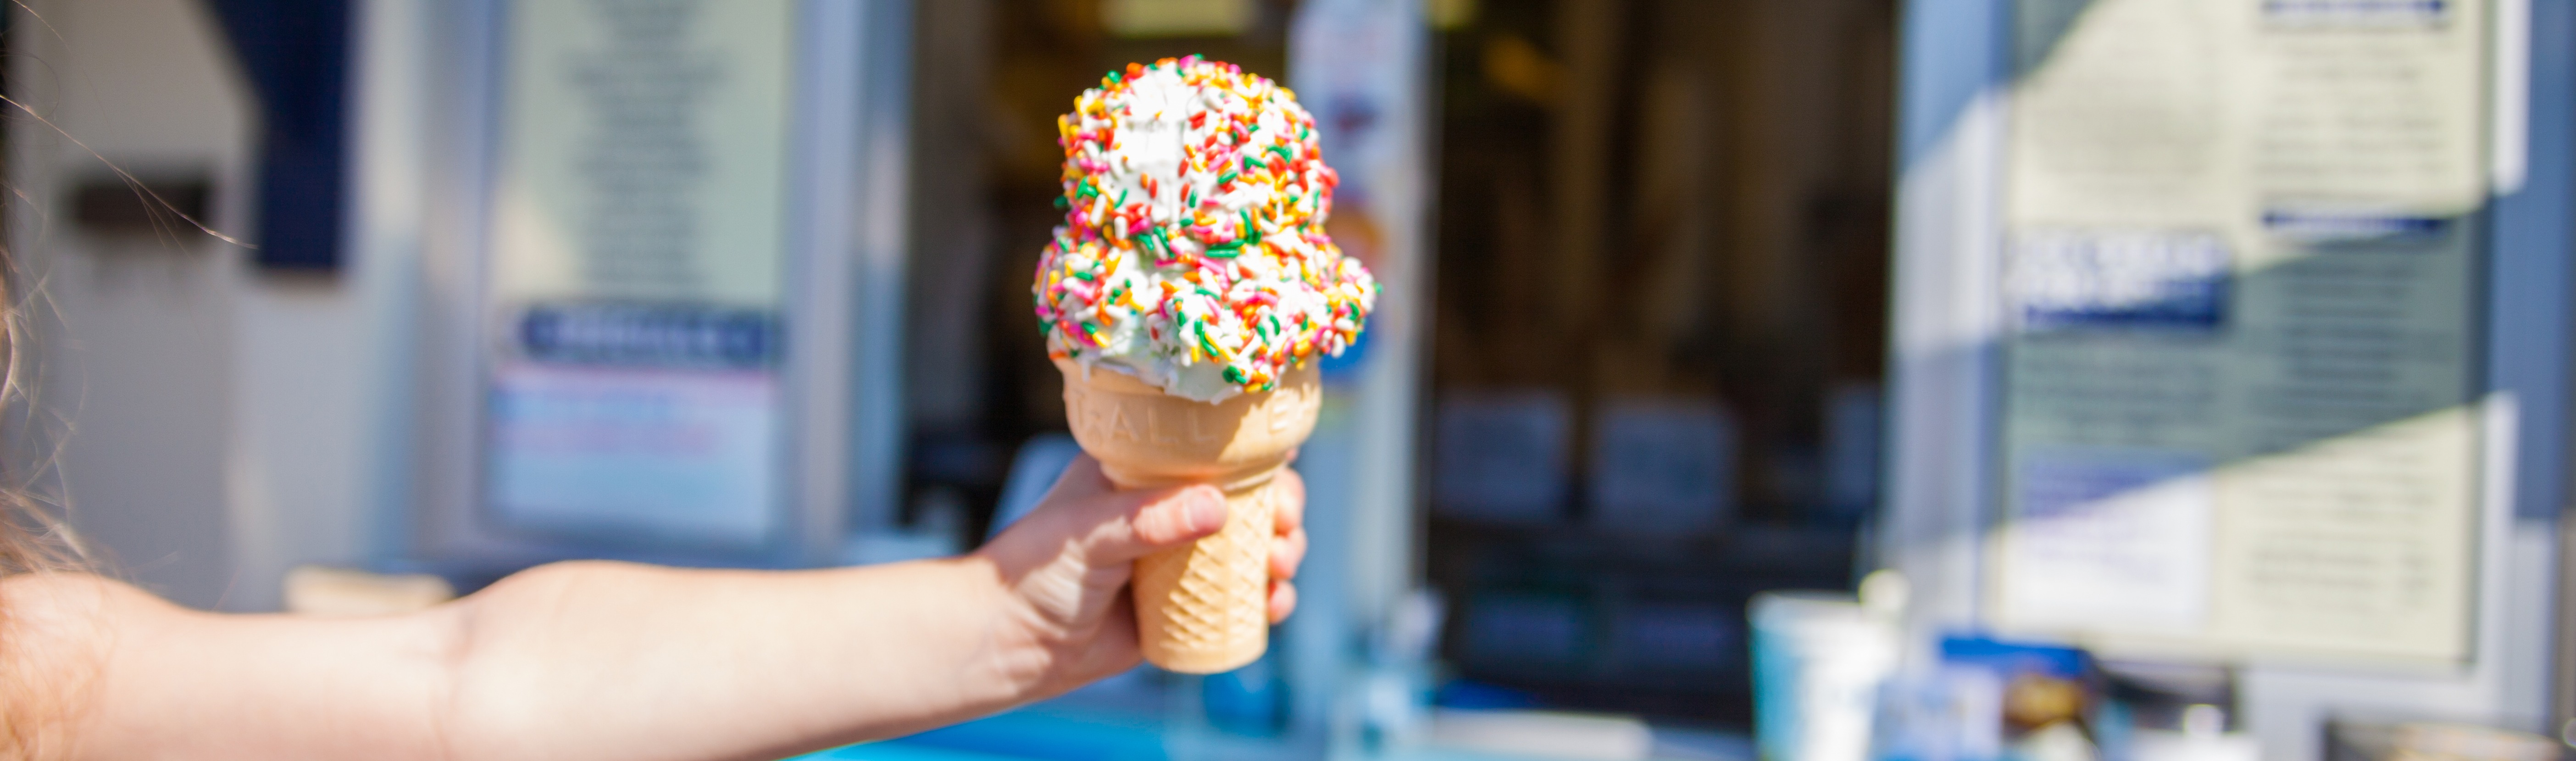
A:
[482, 0, 794, 544]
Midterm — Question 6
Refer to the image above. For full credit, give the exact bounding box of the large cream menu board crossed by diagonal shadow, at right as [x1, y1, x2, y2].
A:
[1986, 0, 2488, 663]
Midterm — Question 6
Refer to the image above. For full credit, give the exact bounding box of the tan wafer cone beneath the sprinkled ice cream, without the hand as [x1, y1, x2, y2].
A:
[1056, 359, 1321, 673]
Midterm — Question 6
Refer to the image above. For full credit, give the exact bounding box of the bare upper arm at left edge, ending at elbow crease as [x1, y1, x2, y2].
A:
[36, 575, 453, 761]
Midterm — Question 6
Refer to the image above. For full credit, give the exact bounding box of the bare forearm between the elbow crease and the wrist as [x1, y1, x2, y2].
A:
[448, 557, 1028, 758]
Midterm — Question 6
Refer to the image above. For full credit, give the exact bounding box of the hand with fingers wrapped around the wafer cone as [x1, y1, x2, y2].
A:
[976, 454, 1306, 696]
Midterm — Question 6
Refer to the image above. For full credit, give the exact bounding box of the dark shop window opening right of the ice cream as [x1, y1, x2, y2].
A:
[1425, 0, 1896, 730]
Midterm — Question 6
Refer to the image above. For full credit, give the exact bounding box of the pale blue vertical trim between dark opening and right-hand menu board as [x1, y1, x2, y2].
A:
[1873, 0, 2012, 624]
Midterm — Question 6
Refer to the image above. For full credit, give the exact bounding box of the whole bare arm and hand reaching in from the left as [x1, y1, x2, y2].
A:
[15, 459, 1304, 758]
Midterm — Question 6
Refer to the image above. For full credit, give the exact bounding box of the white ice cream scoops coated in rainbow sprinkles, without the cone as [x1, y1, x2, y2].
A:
[1033, 57, 1378, 402]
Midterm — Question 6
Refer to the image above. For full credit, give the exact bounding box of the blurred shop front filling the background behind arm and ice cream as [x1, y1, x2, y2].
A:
[0, 0, 2576, 761]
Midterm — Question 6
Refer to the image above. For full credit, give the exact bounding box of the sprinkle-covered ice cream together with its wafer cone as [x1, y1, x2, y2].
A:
[1030, 57, 1378, 673]
